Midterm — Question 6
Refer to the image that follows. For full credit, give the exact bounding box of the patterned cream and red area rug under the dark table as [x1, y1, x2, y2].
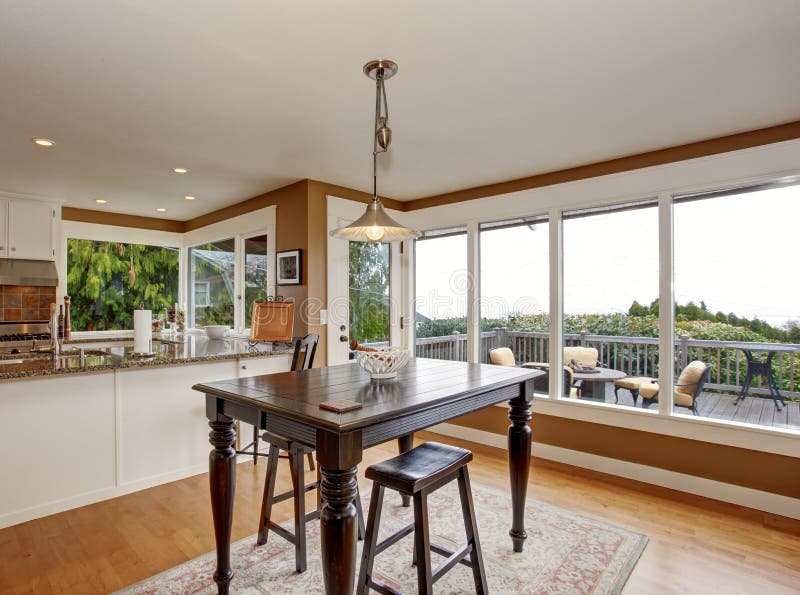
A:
[118, 482, 647, 595]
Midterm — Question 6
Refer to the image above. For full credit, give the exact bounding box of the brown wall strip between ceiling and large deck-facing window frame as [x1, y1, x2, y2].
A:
[402, 121, 800, 211]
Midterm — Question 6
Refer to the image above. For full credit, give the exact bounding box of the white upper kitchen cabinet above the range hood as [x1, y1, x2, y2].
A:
[6, 200, 55, 260]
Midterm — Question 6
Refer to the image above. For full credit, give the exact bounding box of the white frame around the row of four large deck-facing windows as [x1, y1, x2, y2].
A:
[403, 140, 800, 457]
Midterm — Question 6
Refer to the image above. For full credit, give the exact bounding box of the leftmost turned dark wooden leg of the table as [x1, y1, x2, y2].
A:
[208, 415, 236, 595]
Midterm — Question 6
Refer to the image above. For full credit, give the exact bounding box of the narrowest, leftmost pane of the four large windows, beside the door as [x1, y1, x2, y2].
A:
[415, 231, 469, 361]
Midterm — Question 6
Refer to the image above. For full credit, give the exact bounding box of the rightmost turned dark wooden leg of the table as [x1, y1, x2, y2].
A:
[508, 395, 531, 552]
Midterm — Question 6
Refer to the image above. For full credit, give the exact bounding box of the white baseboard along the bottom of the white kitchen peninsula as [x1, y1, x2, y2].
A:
[0, 465, 208, 529]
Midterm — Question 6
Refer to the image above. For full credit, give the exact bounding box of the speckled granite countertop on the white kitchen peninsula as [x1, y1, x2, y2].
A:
[0, 334, 294, 380]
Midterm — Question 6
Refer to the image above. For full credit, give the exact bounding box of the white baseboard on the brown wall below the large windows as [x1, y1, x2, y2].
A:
[428, 424, 800, 520]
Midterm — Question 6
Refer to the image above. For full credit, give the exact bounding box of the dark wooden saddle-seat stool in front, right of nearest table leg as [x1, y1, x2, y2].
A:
[356, 442, 488, 595]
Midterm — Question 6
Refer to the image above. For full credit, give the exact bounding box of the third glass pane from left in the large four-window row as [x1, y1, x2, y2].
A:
[563, 201, 659, 409]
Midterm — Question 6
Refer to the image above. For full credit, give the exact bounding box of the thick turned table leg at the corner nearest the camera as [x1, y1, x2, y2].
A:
[317, 430, 362, 595]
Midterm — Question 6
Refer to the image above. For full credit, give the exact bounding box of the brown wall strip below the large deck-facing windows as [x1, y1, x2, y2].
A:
[451, 407, 800, 498]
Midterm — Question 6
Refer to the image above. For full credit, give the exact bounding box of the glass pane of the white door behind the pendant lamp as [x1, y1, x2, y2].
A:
[349, 242, 389, 344]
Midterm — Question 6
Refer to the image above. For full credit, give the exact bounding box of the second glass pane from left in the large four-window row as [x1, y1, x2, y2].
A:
[480, 217, 550, 386]
